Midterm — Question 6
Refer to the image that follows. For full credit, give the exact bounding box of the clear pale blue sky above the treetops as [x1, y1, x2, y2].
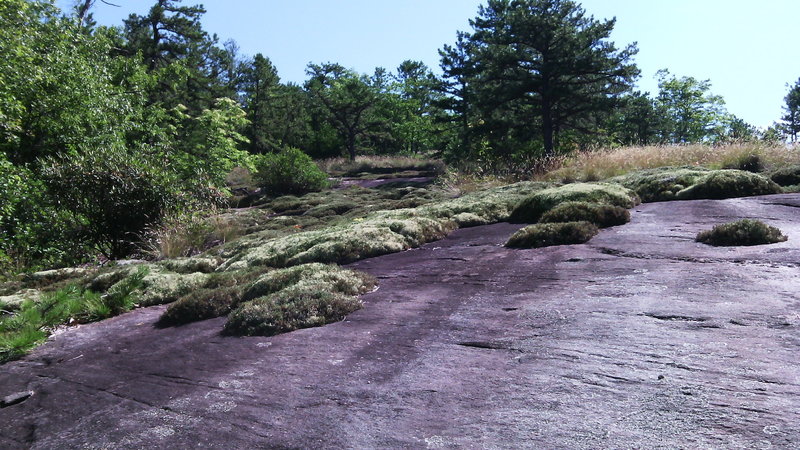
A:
[57, 0, 800, 127]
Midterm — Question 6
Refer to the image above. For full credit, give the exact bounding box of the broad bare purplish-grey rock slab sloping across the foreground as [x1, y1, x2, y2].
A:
[0, 195, 800, 449]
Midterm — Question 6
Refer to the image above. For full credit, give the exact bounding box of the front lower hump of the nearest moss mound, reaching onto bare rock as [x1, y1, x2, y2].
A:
[225, 284, 361, 336]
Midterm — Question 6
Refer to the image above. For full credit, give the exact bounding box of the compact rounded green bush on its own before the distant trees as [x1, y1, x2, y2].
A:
[253, 148, 328, 195]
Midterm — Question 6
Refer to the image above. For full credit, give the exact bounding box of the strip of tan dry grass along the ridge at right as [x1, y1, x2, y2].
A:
[539, 142, 800, 182]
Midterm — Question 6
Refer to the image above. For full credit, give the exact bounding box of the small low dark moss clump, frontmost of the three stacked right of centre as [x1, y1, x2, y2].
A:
[505, 222, 599, 248]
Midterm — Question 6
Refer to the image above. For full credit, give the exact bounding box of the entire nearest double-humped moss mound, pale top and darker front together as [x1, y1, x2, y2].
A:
[225, 264, 376, 336]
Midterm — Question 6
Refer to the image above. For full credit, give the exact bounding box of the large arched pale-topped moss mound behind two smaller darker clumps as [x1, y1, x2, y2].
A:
[509, 183, 639, 223]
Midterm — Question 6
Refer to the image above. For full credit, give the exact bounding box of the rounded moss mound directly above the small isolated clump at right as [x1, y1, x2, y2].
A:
[675, 170, 782, 200]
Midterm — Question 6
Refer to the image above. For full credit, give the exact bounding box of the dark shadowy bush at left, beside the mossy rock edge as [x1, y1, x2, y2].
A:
[43, 151, 178, 259]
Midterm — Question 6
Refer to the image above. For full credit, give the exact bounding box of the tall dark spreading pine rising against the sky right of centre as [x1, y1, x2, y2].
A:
[443, 0, 639, 155]
